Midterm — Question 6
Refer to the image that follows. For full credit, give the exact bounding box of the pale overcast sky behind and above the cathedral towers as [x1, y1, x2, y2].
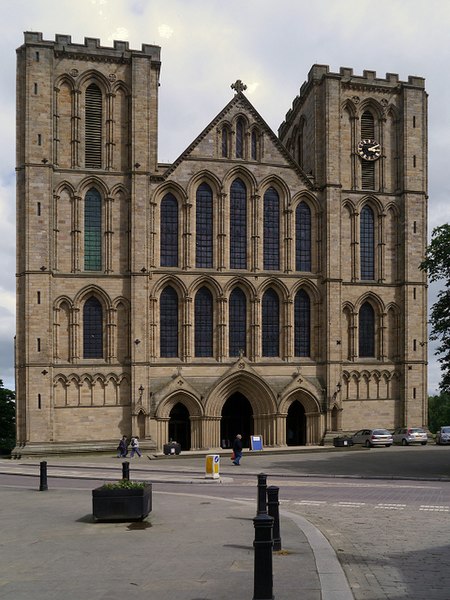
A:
[0, 0, 450, 393]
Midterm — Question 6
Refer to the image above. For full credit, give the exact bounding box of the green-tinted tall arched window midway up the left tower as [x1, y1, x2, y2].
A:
[84, 188, 102, 271]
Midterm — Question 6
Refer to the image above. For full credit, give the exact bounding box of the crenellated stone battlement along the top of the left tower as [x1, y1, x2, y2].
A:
[20, 31, 161, 62]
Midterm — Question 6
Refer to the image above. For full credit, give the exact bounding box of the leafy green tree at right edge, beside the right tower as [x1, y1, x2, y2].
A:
[420, 223, 450, 394]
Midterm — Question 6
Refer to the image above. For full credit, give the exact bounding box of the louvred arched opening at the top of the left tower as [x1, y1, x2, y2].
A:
[84, 83, 103, 169]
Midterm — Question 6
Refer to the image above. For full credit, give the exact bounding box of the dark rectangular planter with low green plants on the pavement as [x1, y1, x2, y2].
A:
[92, 483, 152, 521]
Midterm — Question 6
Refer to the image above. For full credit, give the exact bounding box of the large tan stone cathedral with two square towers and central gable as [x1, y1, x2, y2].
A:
[13, 32, 427, 457]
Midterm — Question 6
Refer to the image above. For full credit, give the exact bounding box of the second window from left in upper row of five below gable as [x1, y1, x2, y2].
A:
[195, 183, 213, 268]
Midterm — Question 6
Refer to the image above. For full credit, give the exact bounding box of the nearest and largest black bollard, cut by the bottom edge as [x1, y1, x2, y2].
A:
[253, 514, 273, 600]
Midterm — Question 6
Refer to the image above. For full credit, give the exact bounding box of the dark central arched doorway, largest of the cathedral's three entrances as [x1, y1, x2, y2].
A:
[220, 392, 253, 448]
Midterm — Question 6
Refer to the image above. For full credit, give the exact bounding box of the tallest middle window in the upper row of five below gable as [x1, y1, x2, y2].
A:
[230, 179, 247, 269]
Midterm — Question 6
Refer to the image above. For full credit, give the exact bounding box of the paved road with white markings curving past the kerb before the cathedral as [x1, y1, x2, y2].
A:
[2, 446, 450, 600]
